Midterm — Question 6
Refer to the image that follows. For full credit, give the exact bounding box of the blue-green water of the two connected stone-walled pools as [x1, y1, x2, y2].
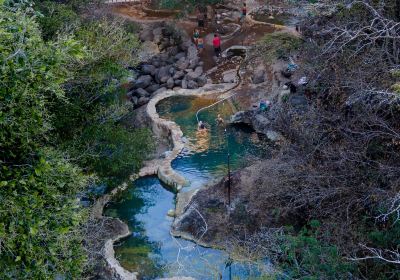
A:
[105, 97, 268, 279]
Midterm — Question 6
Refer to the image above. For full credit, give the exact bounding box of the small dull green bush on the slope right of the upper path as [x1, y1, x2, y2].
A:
[257, 32, 303, 62]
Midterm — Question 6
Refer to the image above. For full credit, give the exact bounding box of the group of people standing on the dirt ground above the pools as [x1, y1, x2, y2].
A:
[193, 2, 247, 57]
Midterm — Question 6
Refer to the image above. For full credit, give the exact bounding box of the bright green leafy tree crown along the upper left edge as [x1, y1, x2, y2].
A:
[0, 3, 82, 161]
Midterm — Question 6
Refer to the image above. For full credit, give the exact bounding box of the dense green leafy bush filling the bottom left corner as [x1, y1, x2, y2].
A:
[0, 149, 87, 279]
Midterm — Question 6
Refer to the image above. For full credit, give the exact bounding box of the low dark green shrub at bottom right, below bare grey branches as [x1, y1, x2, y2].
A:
[282, 220, 355, 280]
